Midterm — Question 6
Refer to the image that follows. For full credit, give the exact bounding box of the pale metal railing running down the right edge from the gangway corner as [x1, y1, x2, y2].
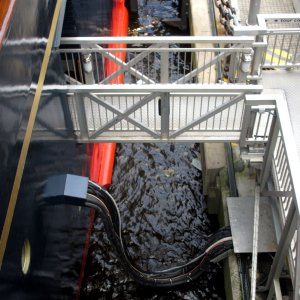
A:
[241, 94, 300, 299]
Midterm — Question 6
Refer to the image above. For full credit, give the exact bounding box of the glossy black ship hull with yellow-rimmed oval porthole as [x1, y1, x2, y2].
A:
[0, 0, 111, 299]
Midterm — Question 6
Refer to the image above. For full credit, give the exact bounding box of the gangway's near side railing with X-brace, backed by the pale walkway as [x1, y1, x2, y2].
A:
[44, 84, 262, 142]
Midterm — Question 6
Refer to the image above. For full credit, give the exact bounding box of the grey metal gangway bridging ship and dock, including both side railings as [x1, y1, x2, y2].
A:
[29, 37, 262, 142]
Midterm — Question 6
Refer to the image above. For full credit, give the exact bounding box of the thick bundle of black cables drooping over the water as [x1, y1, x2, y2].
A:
[85, 181, 233, 287]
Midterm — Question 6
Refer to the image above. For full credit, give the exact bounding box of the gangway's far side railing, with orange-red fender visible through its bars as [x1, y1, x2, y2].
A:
[57, 37, 254, 85]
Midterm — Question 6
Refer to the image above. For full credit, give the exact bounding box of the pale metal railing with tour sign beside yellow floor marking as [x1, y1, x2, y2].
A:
[234, 14, 300, 76]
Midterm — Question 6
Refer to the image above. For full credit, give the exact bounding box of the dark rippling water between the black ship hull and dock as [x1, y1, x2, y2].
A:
[81, 0, 223, 299]
